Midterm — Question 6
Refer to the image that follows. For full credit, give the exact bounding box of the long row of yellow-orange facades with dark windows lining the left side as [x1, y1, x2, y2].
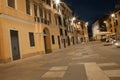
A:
[0, 0, 86, 62]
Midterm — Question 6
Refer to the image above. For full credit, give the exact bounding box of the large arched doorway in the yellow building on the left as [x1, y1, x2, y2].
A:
[43, 28, 52, 53]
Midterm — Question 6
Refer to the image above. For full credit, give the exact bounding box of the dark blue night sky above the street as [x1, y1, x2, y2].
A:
[62, 0, 116, 35]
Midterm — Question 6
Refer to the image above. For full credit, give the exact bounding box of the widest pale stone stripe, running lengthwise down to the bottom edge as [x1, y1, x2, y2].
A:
[85, 63, 110, 80]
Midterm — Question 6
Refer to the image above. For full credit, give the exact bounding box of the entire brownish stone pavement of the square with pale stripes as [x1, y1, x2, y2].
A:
[0, 42, 120, 80]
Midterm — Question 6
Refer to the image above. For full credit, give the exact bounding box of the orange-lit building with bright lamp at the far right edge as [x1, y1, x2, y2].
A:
[105, 10, 120, 40]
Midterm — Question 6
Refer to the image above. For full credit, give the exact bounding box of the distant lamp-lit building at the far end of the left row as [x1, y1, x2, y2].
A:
[72, 19, 89, 44]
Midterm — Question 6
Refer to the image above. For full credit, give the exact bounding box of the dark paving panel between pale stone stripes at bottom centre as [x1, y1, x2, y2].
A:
[64, 64, 87, 80]
